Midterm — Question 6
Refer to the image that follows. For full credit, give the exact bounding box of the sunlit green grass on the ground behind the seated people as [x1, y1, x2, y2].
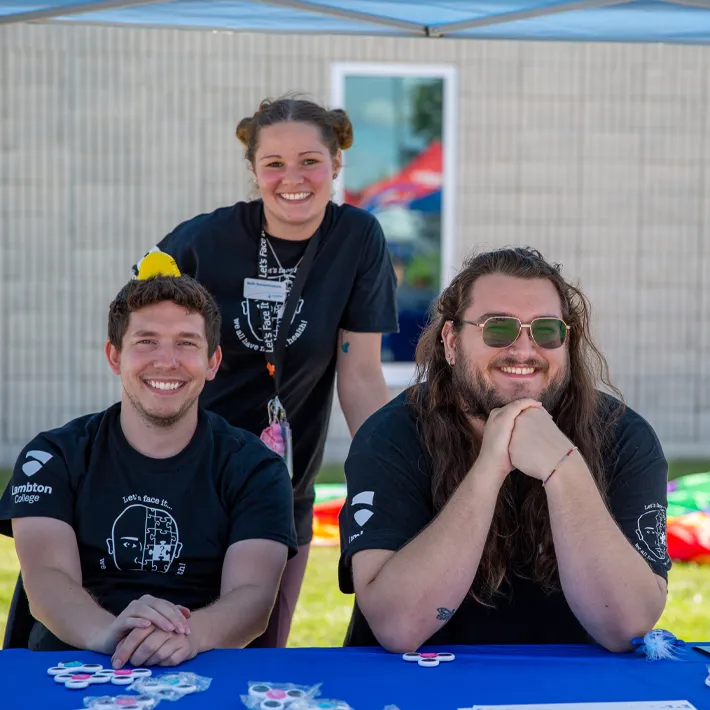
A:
[0, 460, 710, 647]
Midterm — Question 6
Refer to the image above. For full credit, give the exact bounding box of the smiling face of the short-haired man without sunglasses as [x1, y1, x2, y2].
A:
[106, 301, 221, 427]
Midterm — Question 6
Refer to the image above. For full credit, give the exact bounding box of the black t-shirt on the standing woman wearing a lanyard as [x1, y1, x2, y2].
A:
[135, 200, 397, 544]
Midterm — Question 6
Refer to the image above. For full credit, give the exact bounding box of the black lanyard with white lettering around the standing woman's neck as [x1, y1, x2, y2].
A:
[257, 227, 321, 397]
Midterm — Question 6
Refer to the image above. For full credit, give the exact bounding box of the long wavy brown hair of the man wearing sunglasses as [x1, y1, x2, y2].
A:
[410, 247, 623, 604]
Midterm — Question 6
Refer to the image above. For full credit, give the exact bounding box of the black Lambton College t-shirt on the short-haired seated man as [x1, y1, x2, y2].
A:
[0, 404, 296, 647]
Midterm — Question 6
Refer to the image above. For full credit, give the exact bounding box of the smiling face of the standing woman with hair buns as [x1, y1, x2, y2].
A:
[253, 122, 341, 238]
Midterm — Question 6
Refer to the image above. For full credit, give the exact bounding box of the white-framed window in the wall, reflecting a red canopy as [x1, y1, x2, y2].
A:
[333, 63, 456, 386]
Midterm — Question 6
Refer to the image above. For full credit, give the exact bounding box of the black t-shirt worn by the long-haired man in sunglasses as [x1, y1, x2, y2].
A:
[339, 390, 670, 646]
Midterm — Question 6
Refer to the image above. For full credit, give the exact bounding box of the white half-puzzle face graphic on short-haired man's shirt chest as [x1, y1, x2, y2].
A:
[106, 505, 182, 573]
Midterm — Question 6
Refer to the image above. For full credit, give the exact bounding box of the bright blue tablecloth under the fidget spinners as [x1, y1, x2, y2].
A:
[0, 645, 710, 710]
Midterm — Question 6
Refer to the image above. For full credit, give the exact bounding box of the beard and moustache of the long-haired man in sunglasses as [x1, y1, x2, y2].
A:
[452, 353, 570, 420]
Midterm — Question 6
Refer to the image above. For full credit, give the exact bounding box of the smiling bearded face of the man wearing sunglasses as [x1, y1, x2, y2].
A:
[442, 274, 569, 418]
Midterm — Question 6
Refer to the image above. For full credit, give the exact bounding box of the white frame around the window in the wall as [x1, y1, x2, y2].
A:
[331, 62, 458, 388]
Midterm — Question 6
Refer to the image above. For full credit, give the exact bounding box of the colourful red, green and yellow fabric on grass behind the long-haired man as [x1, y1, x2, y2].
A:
[313, 473, 710, 564]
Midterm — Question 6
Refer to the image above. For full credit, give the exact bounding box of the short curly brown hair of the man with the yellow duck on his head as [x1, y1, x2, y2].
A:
[108, 275, 221, 357]
